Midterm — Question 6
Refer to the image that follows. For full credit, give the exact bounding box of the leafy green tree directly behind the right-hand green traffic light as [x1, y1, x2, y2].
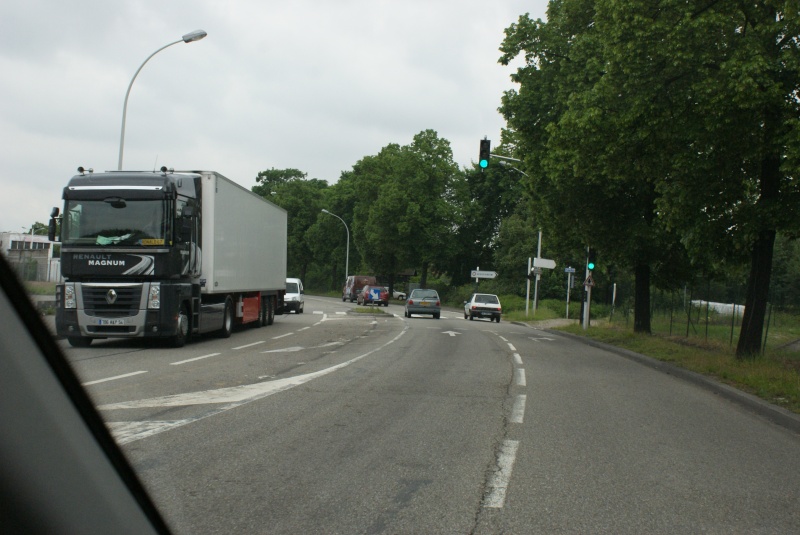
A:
[501, 0, 692, 333]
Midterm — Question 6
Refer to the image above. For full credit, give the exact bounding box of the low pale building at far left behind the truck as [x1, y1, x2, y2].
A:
[0, 232, 61, 282]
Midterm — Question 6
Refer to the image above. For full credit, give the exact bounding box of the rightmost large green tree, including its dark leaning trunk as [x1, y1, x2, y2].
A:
[598, 0, 800, 358]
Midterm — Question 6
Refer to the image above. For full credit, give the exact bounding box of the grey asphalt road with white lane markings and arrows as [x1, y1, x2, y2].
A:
[63, 297, 800, 534]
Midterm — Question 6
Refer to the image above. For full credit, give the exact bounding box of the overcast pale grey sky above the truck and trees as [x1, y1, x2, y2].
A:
[0, 0, 547, 232]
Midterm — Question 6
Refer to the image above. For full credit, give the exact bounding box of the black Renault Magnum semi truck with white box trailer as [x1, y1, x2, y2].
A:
[49, 167, 287, 347]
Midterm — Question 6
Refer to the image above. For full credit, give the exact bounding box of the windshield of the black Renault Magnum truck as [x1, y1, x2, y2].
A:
[61, 197, 167, 245]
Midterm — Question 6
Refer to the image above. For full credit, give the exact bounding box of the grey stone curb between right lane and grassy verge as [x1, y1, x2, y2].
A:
[514, 322, 800, 434]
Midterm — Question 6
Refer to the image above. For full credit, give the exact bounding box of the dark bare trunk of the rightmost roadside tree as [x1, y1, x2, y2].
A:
[736, 230, 775, 359]
